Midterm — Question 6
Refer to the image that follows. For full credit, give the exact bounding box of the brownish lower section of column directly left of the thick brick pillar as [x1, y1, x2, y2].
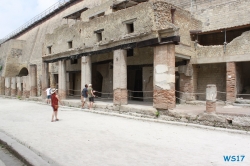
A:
[113, 89, 128, 105]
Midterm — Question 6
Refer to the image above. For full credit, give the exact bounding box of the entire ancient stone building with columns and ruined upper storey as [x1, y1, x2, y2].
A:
[0, 0, 250, 109]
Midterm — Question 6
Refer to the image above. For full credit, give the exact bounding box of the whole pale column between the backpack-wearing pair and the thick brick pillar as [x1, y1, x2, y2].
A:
[113, 50, 128, 105]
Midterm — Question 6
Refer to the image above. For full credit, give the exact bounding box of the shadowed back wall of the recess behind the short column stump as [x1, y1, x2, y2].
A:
[196, 63, 226, 101]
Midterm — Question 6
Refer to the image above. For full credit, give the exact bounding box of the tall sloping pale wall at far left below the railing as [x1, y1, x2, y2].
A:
[0, 0, 111, 91]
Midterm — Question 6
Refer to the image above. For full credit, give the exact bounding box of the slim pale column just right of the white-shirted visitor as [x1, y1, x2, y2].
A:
[58, 60, 67, 99]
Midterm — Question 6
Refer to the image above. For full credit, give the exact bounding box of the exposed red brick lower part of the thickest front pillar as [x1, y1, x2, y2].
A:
[153, 90, 176, 110]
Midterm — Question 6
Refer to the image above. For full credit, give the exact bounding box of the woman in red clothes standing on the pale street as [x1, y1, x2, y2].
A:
[51, 88, 63, 122]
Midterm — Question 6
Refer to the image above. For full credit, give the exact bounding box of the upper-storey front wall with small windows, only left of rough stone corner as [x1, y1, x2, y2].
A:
[44, 3, 155, 55]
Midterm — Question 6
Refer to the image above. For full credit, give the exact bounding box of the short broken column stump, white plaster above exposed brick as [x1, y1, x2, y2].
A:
[206, 84, 217, 113]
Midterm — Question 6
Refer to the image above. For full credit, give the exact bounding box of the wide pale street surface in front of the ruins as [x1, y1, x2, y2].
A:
[0, 98, 250, 166]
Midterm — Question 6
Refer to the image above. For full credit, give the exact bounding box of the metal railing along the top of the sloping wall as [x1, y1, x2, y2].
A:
[0, 0, 74, 44]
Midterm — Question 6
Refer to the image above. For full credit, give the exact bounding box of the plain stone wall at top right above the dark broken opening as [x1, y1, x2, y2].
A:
[164, 0, 250, 31]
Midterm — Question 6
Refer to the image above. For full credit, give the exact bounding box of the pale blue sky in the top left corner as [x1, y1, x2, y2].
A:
[0, 0, 59, 39]
